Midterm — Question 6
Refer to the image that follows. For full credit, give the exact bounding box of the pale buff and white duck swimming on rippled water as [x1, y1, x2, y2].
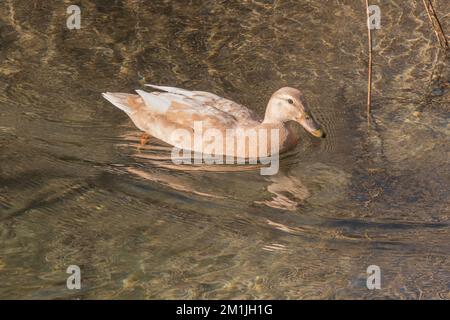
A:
[102, 84, 325, 158]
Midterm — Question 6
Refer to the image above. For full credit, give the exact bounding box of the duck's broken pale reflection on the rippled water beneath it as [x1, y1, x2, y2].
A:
[119, 131, 310, 211]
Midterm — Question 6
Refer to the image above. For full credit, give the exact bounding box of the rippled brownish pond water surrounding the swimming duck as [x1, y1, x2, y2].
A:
[0, 0, 450, 299]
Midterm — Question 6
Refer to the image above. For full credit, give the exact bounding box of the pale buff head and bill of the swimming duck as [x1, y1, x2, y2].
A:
[264, 87, 325, 138]
